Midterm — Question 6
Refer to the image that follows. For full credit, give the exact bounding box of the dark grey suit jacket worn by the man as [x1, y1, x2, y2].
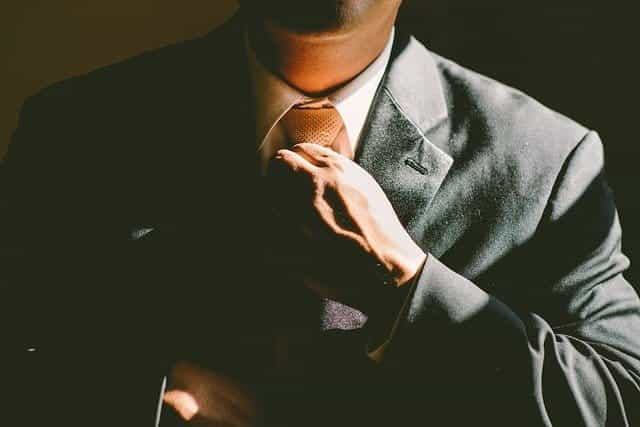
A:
[1, 13, 640, 426]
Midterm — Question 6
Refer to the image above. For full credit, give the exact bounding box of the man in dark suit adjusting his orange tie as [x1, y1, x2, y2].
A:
[2, 0, 640, 426]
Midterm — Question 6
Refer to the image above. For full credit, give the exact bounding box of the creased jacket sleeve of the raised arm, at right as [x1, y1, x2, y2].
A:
[386, 133, 640, 426]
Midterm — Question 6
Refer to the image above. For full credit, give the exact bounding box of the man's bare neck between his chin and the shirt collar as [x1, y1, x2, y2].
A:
[249, 11, 396, 96]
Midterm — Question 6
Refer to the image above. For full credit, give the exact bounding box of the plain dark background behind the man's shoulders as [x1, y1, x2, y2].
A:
[0, 0, 640, 288]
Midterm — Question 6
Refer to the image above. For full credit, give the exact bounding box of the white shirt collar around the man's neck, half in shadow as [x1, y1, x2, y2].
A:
[245, 28, 395, 149]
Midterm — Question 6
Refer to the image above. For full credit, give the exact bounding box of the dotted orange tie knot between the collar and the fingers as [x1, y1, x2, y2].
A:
[281, 100, 353, 159]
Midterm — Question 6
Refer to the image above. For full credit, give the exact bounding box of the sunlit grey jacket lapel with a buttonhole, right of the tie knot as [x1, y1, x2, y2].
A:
[355, 30, 453, 242]
